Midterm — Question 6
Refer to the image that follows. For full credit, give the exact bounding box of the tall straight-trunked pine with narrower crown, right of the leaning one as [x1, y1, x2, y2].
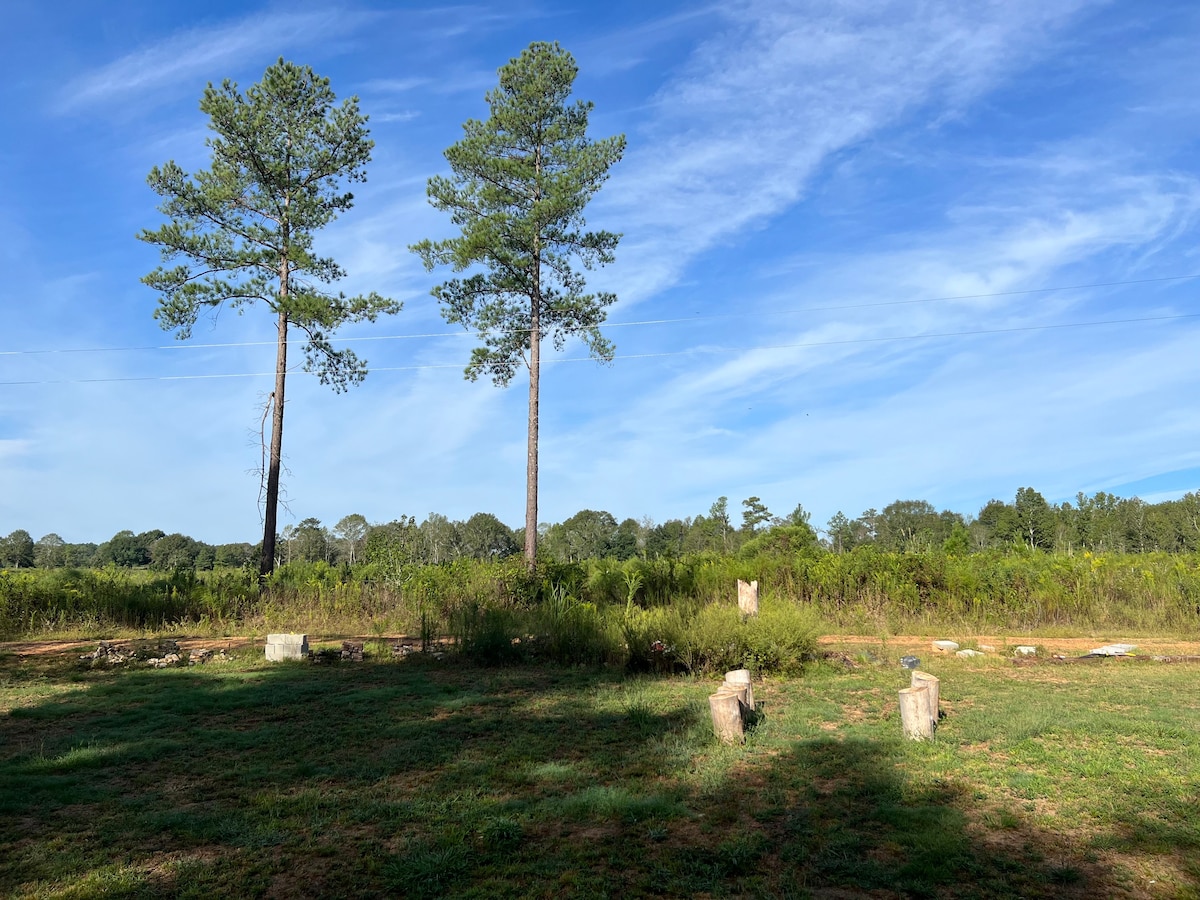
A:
[413, 42, 625, 568]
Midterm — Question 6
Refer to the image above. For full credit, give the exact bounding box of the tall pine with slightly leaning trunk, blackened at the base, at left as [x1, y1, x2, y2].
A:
[138, 58, 400, 575]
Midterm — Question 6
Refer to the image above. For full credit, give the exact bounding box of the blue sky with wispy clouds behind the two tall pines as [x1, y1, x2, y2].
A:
[0, 0, 1200, 542]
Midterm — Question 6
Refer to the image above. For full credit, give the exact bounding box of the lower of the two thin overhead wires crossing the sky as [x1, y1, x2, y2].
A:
[0, 313, 1200, 388]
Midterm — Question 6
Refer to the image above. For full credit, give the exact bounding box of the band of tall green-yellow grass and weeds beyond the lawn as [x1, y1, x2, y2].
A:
[0, 547, 1200, 652]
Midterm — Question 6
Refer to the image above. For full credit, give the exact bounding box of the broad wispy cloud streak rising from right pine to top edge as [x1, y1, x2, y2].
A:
[599, 0, 1099, 299]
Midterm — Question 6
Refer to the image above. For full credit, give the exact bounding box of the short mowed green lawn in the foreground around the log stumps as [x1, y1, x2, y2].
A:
[0, 644, 1200, 898]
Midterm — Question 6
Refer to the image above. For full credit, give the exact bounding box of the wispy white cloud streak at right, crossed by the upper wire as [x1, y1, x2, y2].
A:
[633, 179, 1200, 416]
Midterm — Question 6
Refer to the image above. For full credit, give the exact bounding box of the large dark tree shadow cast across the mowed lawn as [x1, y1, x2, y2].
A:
[0, 659, 1170, 898]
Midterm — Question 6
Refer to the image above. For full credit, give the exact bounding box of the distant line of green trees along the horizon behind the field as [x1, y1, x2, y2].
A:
[7, 487, 1200, 570]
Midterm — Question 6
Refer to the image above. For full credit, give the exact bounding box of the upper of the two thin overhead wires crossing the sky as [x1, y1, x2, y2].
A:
[0, 274, 1200, 356]
